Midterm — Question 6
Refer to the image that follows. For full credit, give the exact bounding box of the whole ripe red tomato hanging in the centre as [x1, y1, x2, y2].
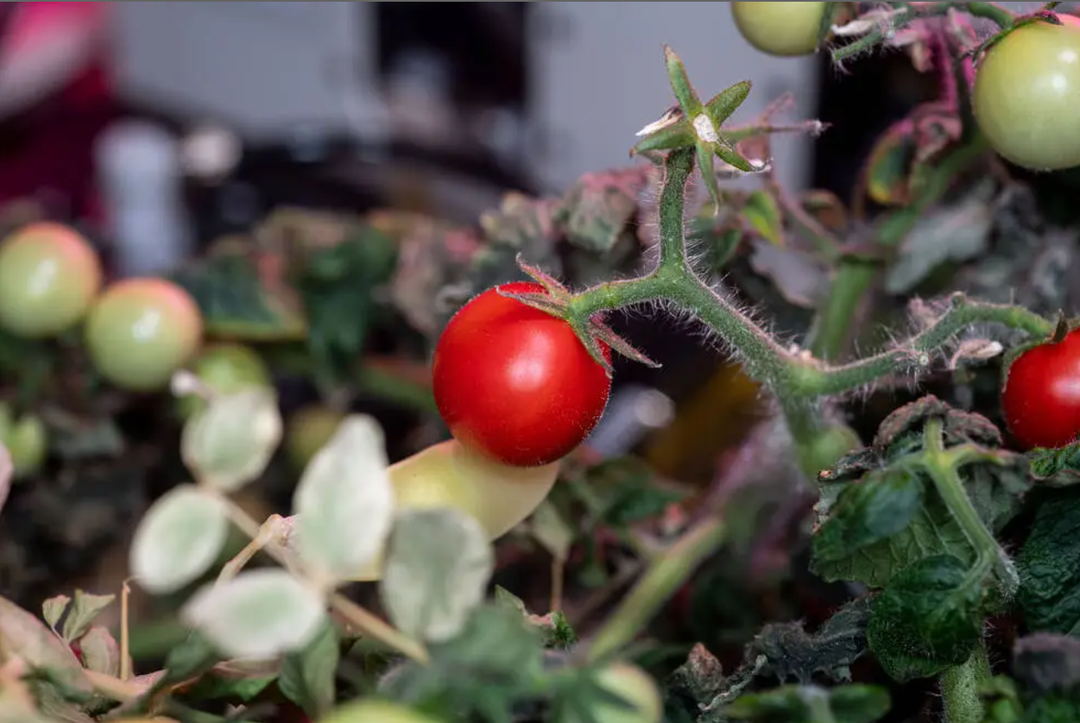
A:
[433, 283, 611, 467]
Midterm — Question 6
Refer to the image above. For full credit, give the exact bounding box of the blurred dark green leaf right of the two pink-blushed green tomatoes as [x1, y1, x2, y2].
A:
[170, 251, 307, 342]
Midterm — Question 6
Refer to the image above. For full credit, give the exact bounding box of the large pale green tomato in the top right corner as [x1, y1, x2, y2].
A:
[973, 15, 1080, 171]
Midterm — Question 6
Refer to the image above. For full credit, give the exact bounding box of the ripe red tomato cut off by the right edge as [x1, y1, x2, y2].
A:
[1001, 331, 1080, 447]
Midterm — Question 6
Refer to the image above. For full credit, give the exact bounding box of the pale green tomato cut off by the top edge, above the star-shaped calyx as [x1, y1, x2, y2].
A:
[731, 2, 828, 56]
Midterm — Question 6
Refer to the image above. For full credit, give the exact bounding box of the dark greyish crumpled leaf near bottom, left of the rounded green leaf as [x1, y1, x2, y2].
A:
[744, 600, 869, 685]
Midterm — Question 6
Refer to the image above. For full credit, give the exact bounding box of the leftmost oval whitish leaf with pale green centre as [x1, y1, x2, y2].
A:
[131, 485, 229, 594]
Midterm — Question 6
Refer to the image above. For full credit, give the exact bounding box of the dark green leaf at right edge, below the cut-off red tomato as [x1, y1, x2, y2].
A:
[1016, 487, 1080, 637]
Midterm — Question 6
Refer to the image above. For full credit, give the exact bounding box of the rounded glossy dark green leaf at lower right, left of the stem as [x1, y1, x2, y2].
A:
[866, 554, 984, 683]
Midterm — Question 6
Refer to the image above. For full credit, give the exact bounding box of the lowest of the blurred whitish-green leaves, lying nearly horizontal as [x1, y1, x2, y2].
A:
[180, 568, 326, 659]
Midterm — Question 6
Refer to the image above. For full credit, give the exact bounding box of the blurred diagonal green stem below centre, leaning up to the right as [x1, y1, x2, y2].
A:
[588, 517, 726, 661]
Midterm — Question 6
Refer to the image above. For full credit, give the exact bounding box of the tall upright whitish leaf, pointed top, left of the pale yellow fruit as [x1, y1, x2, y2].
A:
[293, 415, 394, 581]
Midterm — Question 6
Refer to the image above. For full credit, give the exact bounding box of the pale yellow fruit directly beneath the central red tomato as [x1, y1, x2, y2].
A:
[353, 440, 559, 580]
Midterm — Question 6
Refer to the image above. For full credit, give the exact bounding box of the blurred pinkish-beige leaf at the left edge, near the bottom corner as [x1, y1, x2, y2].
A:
[0, 598, 91, 693]
